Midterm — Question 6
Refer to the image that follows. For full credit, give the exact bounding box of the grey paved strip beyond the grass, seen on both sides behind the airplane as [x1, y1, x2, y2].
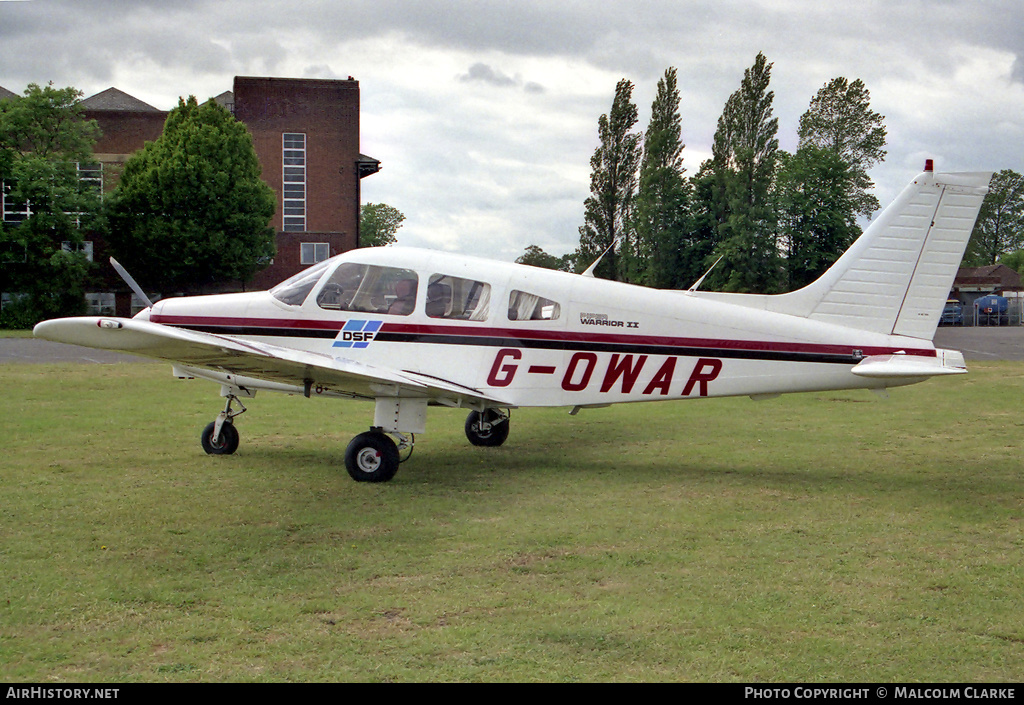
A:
[0, 326, 1024, 364]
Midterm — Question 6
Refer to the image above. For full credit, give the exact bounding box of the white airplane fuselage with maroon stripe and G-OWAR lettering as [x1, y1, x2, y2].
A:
[148, 248, 935, 407]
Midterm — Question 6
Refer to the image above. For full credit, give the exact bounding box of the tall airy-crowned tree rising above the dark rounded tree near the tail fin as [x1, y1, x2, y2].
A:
[799, 77, 886, 216]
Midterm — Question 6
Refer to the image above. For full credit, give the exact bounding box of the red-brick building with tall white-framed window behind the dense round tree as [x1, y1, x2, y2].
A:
[0, 76, 380, 313]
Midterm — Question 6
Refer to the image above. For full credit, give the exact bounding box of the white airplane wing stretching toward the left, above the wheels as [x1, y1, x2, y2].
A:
[34, 317, 511, 406]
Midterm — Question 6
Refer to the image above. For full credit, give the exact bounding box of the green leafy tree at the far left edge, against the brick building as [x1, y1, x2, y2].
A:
[0, 83, 100, 328]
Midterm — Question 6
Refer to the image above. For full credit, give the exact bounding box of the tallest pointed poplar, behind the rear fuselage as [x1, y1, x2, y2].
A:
[707, 52, 781, 293]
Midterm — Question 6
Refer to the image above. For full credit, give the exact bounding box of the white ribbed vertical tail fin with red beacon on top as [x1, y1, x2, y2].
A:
[766, 170, 991, 340]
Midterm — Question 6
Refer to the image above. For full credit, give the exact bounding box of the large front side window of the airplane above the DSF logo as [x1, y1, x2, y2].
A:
[316, 262, 419, 316]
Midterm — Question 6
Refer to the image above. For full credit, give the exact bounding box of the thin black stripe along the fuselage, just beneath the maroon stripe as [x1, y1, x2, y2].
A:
[177, 326, 863, 365]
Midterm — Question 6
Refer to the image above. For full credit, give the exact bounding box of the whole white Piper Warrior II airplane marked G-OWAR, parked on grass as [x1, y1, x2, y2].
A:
[35, 166, 991, 482]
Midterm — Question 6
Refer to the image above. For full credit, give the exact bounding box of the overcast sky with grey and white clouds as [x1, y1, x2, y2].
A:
[0, 0, 1024, 260]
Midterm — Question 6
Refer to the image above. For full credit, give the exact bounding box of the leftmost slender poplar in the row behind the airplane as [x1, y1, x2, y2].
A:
[575, 79, 640, 279]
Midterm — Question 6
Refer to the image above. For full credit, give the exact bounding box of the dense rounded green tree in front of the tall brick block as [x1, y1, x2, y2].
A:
[109, 96, 275, 292]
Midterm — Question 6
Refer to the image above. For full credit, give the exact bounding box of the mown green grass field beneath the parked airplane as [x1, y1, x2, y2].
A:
[0, 363, 1024, 682]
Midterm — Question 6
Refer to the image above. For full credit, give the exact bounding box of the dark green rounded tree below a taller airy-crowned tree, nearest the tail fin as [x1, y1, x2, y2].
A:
[776, 144, 860, 289]
